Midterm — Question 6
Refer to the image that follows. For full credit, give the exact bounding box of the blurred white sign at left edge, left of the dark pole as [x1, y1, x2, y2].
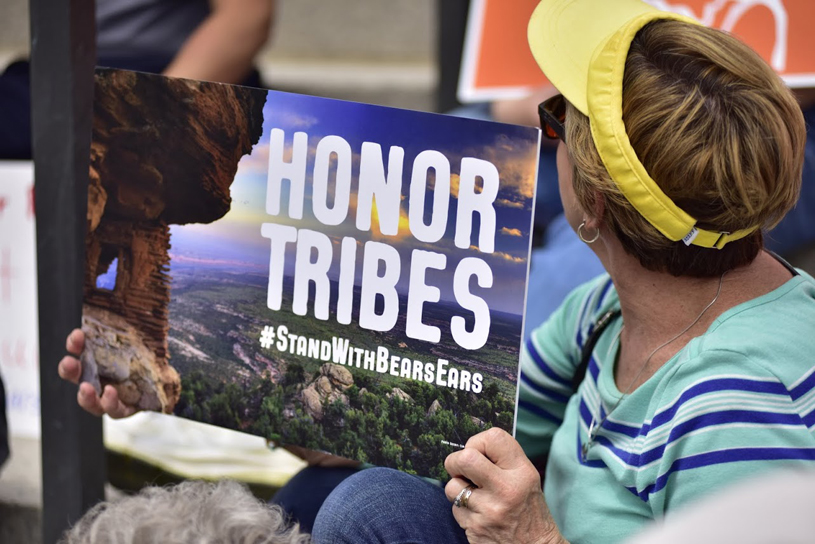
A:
[0, 161, 40, 438]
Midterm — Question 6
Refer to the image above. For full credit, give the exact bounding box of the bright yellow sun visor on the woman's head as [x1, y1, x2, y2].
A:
[527, 0, 758, 249]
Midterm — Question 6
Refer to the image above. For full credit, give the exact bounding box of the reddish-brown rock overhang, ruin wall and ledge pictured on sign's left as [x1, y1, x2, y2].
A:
[84, 70, 266, 412]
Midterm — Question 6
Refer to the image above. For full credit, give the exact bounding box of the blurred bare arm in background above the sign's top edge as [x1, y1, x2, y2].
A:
[164, 0, 275, 83]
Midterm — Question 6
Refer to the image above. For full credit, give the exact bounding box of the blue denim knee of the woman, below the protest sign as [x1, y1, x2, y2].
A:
[312, 468, 467, 544]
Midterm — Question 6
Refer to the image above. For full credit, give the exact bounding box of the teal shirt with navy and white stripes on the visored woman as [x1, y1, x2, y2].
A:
[516, 273, 815, 543]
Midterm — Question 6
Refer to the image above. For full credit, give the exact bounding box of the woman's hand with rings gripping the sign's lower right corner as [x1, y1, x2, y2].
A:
[444, 427, 566, 544]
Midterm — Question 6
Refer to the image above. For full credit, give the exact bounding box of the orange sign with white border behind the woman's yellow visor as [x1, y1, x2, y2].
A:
[460, 0, 815, 100]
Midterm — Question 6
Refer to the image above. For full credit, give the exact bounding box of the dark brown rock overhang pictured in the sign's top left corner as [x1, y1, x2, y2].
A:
[89, 70, 266, 224]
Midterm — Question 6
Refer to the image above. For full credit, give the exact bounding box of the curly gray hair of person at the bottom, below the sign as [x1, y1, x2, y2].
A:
[61, 480, 311, 544]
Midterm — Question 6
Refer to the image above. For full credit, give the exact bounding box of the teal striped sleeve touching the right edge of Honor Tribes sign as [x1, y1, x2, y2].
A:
[515, 276, 611, 459]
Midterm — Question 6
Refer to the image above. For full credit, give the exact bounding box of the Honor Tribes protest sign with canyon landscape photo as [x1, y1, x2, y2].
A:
[83, 70, 539, 476]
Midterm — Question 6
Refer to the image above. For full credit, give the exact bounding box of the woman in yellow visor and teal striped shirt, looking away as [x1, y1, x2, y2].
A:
[306, 0, 815, 543]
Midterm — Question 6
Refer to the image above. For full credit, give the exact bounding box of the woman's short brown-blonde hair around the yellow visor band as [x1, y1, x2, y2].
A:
[566, 20, 806, 277]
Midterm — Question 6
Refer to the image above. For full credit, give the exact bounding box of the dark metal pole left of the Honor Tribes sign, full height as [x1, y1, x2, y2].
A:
[30, 0, 107, 544]
